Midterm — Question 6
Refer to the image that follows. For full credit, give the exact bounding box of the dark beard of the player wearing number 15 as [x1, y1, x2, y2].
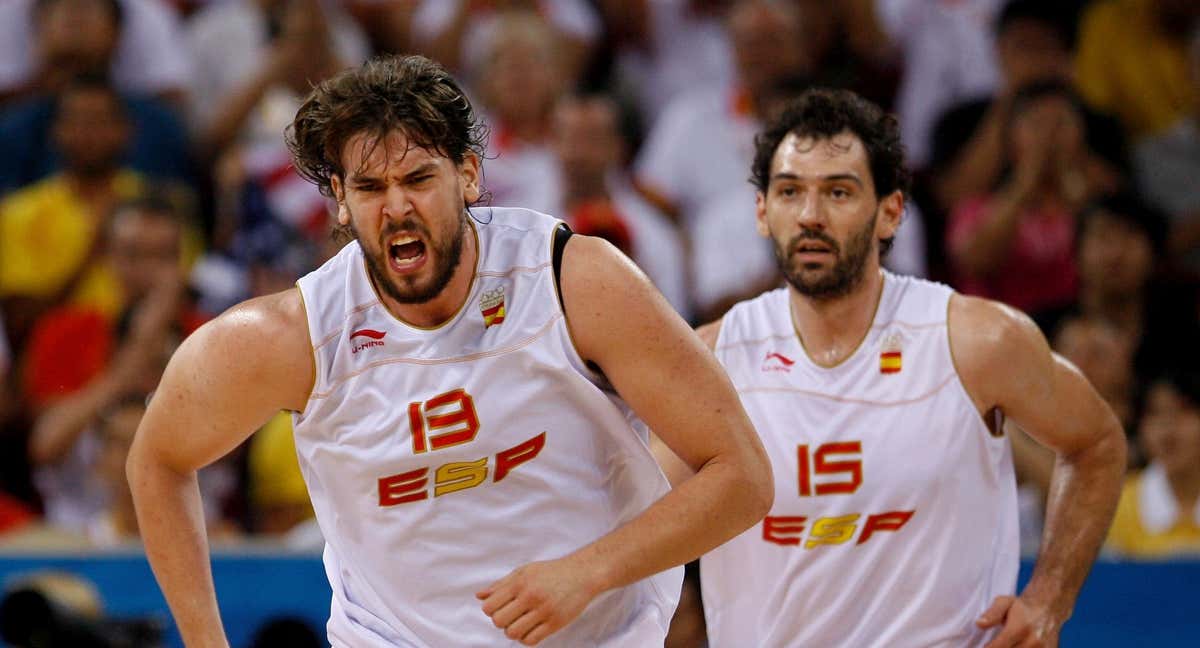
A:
[772, 214, 878, 300]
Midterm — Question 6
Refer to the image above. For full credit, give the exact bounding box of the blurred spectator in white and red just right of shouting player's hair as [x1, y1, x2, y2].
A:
[476, 11, 565, 214]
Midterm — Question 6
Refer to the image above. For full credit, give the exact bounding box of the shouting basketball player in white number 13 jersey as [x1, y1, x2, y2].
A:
[128, 56, 773, 648]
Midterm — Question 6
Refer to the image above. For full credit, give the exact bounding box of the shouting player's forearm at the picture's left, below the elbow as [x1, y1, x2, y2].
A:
[128, 452, 228, 648]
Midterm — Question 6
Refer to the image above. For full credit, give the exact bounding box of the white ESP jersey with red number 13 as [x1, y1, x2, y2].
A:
[294, 208, 682, 648]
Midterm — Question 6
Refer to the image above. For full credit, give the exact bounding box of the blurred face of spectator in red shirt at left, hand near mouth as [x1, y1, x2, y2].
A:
[108, 206, 182, 301]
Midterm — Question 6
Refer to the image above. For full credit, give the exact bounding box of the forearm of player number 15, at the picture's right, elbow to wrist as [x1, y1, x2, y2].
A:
[1021, 421, 1126, 620]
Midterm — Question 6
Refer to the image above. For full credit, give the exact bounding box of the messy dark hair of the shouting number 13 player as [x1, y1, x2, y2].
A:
[286, 55, 487, 196]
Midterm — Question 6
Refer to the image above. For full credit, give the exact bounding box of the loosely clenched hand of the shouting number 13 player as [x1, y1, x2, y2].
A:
[475, 558, 600, 646]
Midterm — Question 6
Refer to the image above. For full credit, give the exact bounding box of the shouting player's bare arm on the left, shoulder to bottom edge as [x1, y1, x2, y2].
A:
[127, 289, 313, 647]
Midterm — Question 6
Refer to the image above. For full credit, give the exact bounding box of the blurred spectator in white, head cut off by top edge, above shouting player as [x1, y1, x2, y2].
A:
[412, 0, 601, 86]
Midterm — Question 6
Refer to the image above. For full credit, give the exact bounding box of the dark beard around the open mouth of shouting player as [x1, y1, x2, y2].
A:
[350, 211, 468, 304]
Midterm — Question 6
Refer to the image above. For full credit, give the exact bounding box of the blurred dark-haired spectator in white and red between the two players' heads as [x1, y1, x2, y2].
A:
[550, 95, 689, 318]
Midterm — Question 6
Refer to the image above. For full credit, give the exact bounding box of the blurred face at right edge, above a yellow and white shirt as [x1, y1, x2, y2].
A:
[1140, 380, 1200, 475]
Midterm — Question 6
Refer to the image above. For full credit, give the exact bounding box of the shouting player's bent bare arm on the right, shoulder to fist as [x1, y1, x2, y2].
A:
[480, 236, 773, 644]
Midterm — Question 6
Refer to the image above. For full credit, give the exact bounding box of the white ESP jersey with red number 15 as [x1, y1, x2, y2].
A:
[700, 274, 1019, 648]
